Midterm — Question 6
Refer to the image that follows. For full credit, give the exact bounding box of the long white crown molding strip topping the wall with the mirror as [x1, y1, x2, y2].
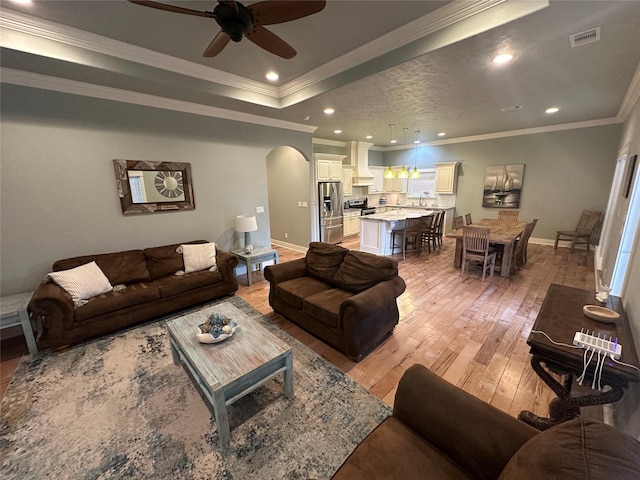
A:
[0, 68, 318, 134]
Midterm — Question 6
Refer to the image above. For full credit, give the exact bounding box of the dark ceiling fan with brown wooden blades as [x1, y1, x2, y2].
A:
[129, 0, 327, 58]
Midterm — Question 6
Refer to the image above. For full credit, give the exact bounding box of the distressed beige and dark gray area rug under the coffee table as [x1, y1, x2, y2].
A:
[0, 297, 391, 480]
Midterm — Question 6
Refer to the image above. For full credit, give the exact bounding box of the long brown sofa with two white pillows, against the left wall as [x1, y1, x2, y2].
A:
[28, 240, 238, 350]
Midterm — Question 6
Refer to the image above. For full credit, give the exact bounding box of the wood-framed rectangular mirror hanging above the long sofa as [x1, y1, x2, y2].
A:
[113, 160, 196, 215]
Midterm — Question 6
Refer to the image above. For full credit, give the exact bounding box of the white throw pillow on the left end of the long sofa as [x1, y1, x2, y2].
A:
[47, 262, 113, 307]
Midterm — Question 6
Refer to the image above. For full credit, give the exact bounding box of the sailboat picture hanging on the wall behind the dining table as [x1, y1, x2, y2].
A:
[482, 163, 524, 208]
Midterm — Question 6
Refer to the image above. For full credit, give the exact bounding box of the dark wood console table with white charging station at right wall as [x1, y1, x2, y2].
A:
[518, 284, 640, 430]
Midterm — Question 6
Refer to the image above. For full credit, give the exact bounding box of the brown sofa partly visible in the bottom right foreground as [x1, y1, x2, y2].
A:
[332, 365, 640, 480]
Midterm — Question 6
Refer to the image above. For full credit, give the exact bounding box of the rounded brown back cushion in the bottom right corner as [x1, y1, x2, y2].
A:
[499, 417, 640, 480]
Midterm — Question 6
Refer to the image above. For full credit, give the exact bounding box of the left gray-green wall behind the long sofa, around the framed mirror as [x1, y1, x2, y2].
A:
[0, 84, 311, 295]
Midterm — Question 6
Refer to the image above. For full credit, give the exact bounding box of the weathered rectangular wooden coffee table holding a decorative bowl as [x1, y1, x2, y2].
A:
[167, 302, 293, 450]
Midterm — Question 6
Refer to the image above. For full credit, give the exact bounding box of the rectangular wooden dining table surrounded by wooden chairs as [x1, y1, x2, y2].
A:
[446, 218, 527, 277]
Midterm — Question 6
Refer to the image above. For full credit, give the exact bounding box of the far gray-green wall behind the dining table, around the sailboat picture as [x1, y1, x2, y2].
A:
[384, 125, 621, 239]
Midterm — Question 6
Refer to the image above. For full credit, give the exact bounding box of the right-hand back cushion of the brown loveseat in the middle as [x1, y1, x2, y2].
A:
[332, 252, 398, 293]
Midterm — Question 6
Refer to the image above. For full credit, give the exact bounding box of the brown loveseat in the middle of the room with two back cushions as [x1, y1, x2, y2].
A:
[264, 242, 406, 361]
